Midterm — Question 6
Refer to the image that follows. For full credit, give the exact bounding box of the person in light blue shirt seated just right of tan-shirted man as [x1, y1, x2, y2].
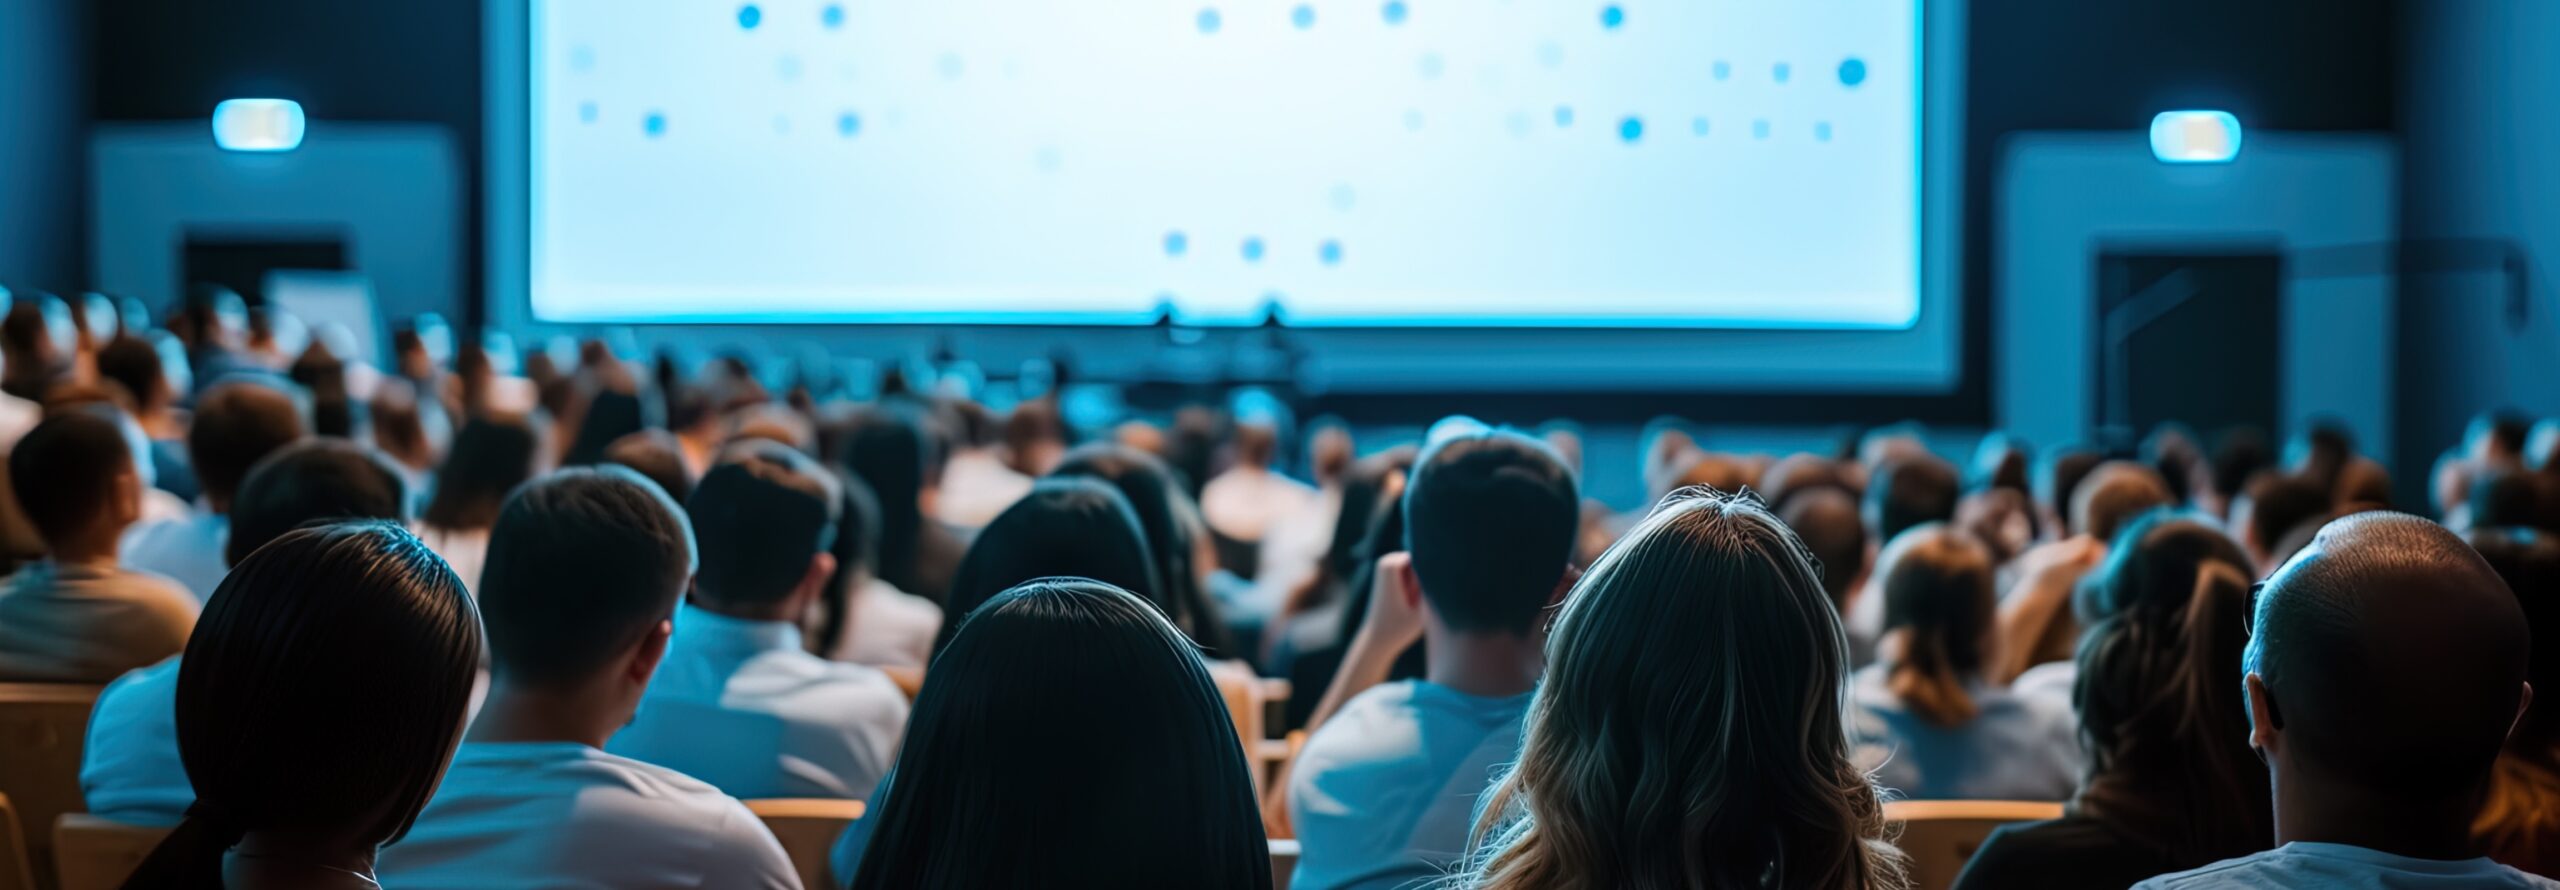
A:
[125, 381, 302, 598]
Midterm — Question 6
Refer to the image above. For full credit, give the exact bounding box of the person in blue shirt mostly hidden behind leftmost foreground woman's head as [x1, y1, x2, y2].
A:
[79, 440, 410, 826]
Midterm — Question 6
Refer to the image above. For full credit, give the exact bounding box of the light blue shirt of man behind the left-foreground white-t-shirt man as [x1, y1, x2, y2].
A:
[604, 606, 906, 800]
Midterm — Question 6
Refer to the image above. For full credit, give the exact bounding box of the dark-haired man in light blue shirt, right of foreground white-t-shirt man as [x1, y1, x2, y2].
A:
[604, 442, 906, 798]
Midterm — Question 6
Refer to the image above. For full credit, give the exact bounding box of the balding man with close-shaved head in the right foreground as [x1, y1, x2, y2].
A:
[2138, 511, 2560, 890]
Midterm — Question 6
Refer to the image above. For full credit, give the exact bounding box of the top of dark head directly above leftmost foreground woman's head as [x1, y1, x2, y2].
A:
[223, 440, 410, 565]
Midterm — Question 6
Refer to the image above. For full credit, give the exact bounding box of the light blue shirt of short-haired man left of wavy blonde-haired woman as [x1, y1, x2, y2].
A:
[1288, 680, 1533, 890]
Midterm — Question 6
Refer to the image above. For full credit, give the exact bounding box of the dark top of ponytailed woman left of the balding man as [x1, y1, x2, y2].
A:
[1956, 813, 2207, 890]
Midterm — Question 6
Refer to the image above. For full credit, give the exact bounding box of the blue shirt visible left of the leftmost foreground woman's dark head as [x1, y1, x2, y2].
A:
[79, 655, 195, 826]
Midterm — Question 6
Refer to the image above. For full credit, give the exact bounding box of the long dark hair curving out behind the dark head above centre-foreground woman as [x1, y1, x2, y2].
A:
[1050, 442, 1236, 657]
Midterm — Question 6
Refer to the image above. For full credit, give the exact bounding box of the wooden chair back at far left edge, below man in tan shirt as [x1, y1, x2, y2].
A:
[0, 683, 100, 875]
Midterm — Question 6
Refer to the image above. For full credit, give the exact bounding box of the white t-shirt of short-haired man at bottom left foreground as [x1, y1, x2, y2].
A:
[376, 742, 801, 890]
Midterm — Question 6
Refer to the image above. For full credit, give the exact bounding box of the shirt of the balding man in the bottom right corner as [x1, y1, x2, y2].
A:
[2132, 841, 2560, 890]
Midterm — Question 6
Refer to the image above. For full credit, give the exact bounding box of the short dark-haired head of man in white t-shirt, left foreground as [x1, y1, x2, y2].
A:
[479, 465, 694, 685]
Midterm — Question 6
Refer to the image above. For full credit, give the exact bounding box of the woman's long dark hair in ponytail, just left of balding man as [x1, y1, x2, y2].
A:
[2071, 511, 2276, 867]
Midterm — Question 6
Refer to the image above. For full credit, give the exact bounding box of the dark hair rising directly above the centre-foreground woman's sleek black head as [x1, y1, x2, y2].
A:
[934, 478, 1165, 654]
